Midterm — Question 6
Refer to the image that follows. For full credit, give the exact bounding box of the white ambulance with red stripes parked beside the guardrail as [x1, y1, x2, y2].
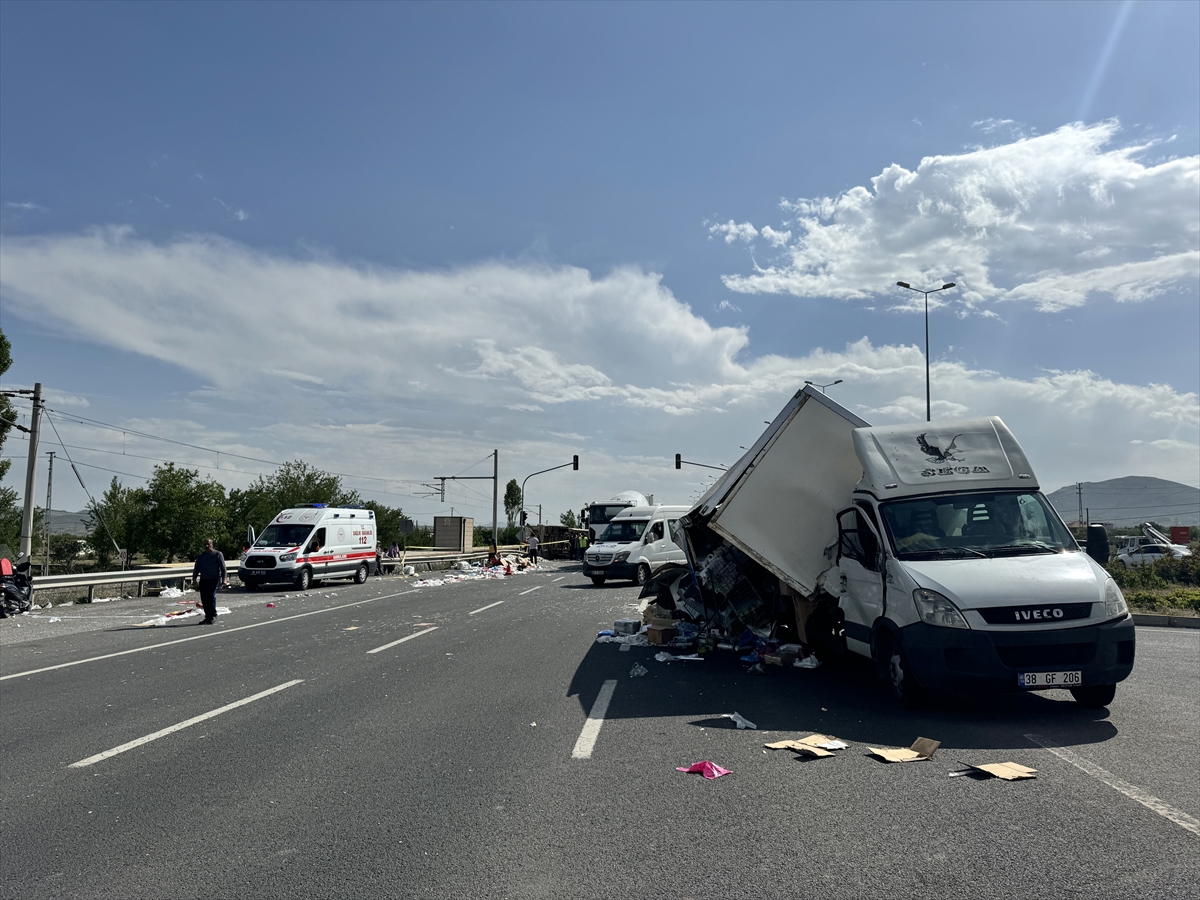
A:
[238, 503, 376, 590]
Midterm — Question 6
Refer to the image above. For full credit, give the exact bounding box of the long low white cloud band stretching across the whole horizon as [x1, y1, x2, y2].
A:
[0, 228, 1200, 516]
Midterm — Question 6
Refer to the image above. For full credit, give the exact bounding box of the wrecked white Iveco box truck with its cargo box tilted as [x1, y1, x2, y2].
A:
[683, 388, 1135, 707]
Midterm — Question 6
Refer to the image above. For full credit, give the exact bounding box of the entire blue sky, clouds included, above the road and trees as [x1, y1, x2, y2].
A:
[0, 1, 1200, 518]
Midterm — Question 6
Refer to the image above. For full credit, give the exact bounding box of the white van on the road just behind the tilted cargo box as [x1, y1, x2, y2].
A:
[583, 506, 690, 584]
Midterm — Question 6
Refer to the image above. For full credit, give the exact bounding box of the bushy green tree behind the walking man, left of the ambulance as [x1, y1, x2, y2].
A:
[139, 462, 227, 563]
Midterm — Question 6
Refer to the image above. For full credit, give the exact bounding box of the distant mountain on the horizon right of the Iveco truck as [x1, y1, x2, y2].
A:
[1046, 475, 1200, 528]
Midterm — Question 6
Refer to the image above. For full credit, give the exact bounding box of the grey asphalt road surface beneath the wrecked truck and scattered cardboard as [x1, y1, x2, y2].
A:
[0, 566, 1200, 900]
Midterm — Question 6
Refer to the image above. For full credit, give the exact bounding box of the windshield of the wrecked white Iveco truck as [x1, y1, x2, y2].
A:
[880, 492, 1079, 559]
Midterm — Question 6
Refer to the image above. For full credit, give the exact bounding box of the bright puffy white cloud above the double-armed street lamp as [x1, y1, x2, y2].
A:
[709, 120, 1200, 311]
